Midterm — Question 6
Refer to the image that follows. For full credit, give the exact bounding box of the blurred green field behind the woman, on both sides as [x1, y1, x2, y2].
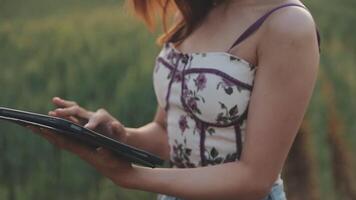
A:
[0, 0, 356, 200]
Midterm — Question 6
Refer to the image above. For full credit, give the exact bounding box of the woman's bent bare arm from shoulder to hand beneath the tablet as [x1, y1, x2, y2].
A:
[32, 9, 319, 200]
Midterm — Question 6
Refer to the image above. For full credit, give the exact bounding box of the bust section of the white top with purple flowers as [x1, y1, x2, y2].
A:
[153, 44, 255, 126]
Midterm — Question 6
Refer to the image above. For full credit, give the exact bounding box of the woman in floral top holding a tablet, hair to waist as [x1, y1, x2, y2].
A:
[29, 0, 319, 200]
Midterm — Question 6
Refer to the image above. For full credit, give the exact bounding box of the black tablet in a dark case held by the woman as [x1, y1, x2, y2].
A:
[0, 107, 164, 167]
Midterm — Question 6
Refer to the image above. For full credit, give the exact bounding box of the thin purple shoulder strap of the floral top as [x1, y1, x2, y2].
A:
[228, 3, 310, 52]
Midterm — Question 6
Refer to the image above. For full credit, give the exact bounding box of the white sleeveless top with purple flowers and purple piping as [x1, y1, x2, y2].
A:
[153, 43, 280, 186]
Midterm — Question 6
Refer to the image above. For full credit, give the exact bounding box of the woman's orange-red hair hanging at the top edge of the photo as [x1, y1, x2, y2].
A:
[131, 0, 216, 44]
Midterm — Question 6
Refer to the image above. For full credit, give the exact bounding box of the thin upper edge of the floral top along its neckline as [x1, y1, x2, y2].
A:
[166, 42, 256, 69]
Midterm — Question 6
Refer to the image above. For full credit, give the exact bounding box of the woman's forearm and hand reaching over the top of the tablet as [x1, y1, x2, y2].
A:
[49, 97, 169, 159]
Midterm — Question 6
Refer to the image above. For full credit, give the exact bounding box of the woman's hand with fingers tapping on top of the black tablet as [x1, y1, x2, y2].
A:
[48, 97, 128, 142]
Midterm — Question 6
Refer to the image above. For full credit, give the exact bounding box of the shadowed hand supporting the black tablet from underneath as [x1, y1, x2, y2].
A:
[27, 126, 135, 188]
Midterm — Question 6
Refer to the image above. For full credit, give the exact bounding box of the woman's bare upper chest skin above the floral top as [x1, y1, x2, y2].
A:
[177, 7, 264, 65]
